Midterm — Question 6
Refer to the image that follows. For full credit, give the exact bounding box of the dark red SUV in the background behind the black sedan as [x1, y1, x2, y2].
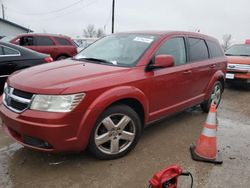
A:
[10, 33, 77, 60]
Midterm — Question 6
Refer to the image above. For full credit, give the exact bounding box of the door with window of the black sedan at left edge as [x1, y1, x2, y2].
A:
[0, 45, 21, 94]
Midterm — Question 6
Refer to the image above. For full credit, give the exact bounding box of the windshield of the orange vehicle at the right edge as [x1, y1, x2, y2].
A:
[225, 44, 250, 56]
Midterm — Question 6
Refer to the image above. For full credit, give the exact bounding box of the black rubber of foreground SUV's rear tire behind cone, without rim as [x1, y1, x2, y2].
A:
[201, 81, 223, 113]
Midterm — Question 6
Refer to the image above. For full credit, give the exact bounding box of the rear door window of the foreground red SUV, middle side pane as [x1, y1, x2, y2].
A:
[188, 38, 208, 61]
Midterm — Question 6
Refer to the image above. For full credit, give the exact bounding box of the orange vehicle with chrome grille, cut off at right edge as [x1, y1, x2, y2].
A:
[225, 44, 250, 85]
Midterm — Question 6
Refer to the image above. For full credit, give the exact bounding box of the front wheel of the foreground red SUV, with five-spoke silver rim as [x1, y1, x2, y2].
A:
[88, 104, 142, 160]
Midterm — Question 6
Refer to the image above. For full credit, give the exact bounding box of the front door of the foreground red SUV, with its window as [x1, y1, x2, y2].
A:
[148, 36, 193, 119]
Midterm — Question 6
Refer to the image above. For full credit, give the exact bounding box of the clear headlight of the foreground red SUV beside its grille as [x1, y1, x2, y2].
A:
[30, 93, 85, 112]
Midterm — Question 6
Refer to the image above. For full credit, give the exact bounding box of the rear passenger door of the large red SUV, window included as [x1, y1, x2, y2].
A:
[188, 37, 216, 100]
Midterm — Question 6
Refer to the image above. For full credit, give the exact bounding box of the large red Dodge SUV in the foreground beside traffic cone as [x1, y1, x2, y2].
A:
[0, 32, 227, 159]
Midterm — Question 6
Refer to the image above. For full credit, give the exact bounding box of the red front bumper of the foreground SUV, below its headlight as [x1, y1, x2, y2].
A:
[0, 102, 84, 152]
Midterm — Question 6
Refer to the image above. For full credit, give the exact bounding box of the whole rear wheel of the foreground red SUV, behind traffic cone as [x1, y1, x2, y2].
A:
[201, 81, 223, 113]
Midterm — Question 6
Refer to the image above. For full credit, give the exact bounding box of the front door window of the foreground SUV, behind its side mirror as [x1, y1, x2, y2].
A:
[156, 37, 186, 65]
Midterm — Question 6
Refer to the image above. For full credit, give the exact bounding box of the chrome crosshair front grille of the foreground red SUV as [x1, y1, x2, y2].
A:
[3, 86, 33, 113]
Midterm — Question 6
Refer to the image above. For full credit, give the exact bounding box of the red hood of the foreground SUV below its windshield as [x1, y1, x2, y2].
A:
[8, 59, 131, 94]
